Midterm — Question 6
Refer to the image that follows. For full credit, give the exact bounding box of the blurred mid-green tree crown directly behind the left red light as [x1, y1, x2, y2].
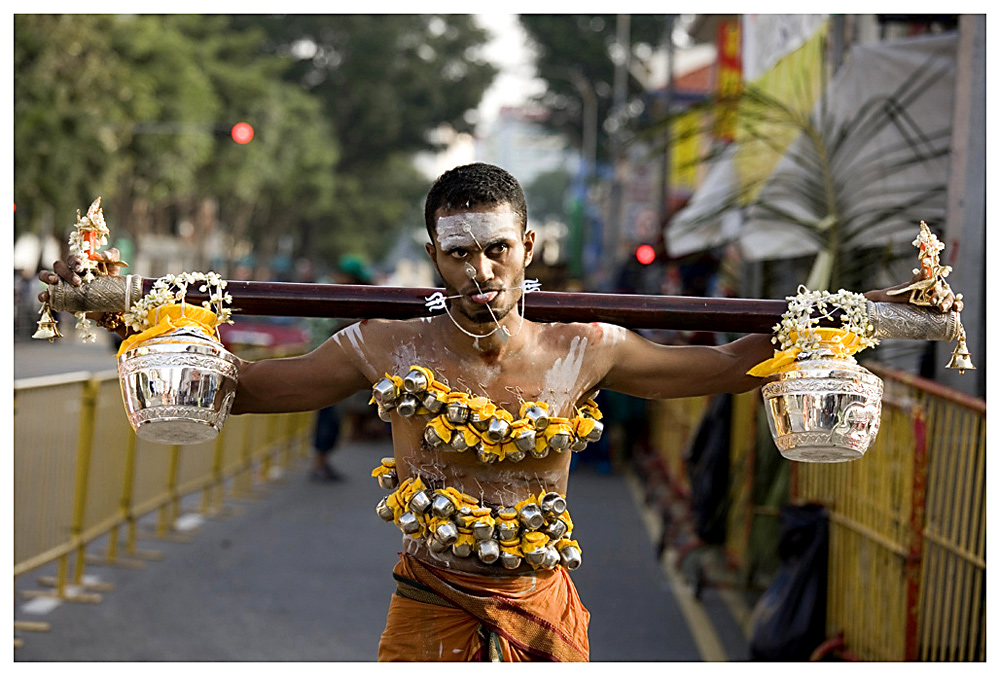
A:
[170, 16, 338, 268]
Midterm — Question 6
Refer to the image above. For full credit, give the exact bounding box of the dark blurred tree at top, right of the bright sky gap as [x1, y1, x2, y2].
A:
[518, 14, 666, 158]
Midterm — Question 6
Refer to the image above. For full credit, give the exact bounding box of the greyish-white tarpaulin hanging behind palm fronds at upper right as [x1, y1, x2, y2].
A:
[666, 33, 958, 260]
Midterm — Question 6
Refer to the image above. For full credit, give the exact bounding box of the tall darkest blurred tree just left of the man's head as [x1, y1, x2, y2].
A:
[234, 15, 497, 259]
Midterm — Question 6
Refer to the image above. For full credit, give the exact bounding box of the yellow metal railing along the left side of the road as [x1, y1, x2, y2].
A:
[14, 352, 313, 630]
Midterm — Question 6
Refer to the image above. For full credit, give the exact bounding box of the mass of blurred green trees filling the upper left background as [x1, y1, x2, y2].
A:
[14, 15, 496, 262]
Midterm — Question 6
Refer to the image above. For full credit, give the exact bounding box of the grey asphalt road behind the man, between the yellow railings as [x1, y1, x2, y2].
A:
[14, 340, 748, 662]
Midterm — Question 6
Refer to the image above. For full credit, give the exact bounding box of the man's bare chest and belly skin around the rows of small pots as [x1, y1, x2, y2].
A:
[331, 317, 625, 575]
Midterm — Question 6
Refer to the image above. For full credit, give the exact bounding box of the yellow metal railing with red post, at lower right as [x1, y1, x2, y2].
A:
[792, 364, 986, 661]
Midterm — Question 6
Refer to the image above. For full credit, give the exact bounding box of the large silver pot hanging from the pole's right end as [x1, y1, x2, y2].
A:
[762, 356, 882, 462]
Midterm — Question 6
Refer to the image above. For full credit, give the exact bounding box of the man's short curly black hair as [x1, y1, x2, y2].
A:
[424, 162, 528, 243]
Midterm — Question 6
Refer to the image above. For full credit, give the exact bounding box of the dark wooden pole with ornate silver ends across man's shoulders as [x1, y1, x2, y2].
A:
[49, 275, 961, 341]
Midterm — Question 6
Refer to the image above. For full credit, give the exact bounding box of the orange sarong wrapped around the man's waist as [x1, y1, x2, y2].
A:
[378, 554, 590, 662]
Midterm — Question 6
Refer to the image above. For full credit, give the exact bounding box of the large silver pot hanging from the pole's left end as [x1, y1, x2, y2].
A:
[118, 327, 239, 445]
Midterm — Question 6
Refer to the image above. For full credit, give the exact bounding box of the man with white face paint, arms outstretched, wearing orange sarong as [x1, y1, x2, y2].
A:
[39, 164, 960, 661]
